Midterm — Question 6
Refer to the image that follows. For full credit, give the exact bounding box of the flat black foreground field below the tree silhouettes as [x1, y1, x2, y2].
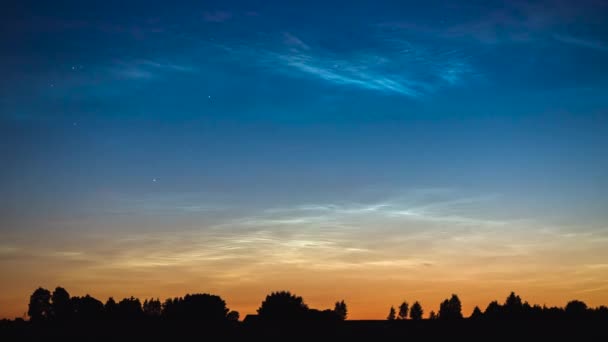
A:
[0, 319, 608, 341]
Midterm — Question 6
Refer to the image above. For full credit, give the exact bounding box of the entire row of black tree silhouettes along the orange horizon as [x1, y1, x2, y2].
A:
[11, 287, 608, 322]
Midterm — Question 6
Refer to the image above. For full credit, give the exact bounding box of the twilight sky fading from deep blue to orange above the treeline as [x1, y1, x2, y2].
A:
[0, 0, 608, 319]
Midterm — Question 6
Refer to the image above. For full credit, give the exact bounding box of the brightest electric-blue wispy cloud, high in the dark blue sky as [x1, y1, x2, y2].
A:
[224, 33, 472, 97]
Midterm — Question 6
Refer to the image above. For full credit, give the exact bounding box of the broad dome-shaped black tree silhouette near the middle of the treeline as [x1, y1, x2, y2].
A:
[258, 291, 308, 320]
